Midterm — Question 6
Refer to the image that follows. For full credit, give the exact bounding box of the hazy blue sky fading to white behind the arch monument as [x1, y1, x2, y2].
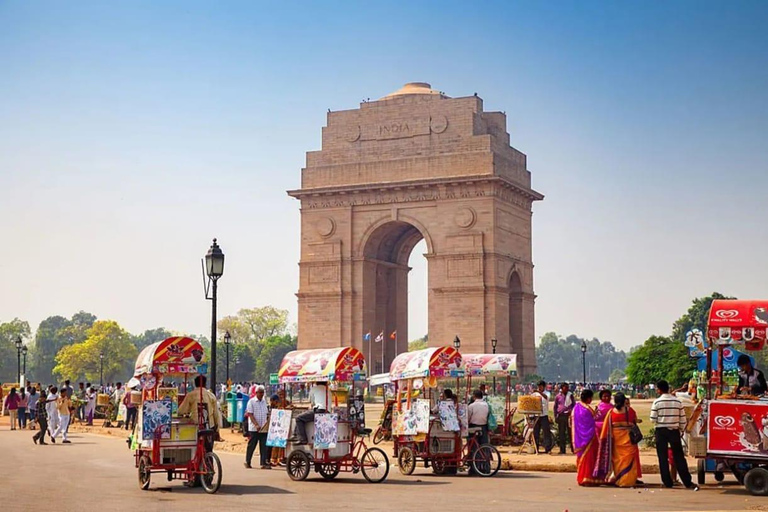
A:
[0, 0, 768, 349]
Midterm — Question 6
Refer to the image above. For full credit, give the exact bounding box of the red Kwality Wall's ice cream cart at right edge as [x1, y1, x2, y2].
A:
[687, 300, 768, 496]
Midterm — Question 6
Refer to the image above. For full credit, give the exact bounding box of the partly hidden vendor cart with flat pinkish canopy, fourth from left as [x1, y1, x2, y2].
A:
[462, 354, 517, 442]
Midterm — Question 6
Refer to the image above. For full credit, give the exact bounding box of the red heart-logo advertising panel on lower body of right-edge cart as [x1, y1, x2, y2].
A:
[707, 400, 768, 456]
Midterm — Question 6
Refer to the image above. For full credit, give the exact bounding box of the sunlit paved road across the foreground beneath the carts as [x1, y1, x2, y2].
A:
[0, 430, 768, 512]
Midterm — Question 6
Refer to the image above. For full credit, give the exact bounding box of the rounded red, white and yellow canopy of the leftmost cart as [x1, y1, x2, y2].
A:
[133, 337, 208, 377]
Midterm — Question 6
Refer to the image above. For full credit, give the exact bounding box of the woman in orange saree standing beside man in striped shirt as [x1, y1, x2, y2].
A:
[593, 393, 638, 487]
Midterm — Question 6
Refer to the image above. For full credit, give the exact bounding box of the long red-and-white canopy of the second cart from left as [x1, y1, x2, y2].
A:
[277, 347, 365, 384]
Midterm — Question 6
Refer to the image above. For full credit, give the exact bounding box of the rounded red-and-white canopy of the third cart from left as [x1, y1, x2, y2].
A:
[389, 347, 464, 382]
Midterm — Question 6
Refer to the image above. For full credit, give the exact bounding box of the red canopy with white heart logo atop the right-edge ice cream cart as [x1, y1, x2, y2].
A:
[707, 300, 768, 350]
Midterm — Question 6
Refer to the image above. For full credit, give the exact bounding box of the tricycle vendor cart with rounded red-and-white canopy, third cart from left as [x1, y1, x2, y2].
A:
[389, 347, 501, 476]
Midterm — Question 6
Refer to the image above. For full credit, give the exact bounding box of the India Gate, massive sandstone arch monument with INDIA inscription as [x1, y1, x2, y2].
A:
[289, 82, 544, 375]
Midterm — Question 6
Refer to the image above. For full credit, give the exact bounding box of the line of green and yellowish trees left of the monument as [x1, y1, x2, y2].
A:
[0, 306, 298, 383]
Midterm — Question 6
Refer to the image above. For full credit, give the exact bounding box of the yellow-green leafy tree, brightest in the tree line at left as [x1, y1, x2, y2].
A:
[53, 320, 138, 382]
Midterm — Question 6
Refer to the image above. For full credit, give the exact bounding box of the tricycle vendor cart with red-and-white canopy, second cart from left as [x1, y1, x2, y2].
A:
[280, 347, 389, 483]
